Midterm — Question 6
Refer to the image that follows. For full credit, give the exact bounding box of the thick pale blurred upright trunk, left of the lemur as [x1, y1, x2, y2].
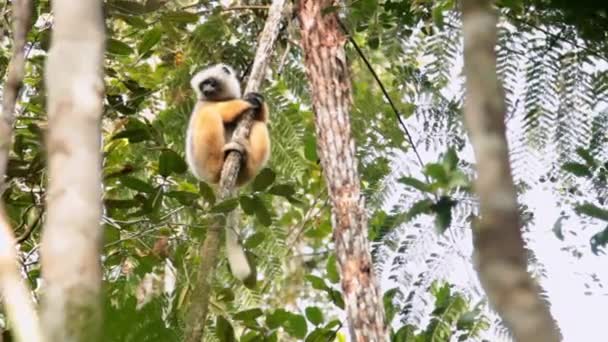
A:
[41, 0, 105, 342]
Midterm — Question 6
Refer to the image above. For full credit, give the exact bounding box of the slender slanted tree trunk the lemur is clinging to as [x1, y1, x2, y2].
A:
[186, 0, 285, 342]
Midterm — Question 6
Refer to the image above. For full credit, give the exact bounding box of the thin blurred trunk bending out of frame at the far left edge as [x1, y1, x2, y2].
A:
[0, 0, 43, 342]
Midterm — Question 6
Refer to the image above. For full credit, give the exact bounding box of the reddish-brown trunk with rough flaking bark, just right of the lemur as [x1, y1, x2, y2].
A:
[299, 0, 387, 342]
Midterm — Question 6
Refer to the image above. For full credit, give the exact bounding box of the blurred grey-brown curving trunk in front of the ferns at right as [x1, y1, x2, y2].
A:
[461, 0, 560, 342]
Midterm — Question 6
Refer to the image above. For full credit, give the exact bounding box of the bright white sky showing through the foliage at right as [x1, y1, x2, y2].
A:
[380, 20, 608, 342]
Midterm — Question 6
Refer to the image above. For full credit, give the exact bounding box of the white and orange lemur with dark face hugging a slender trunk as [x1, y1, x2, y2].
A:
[186, 64, 270, 281]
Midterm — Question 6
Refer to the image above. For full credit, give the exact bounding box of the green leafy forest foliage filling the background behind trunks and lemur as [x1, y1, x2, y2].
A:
[0, 0, 608, 341]
